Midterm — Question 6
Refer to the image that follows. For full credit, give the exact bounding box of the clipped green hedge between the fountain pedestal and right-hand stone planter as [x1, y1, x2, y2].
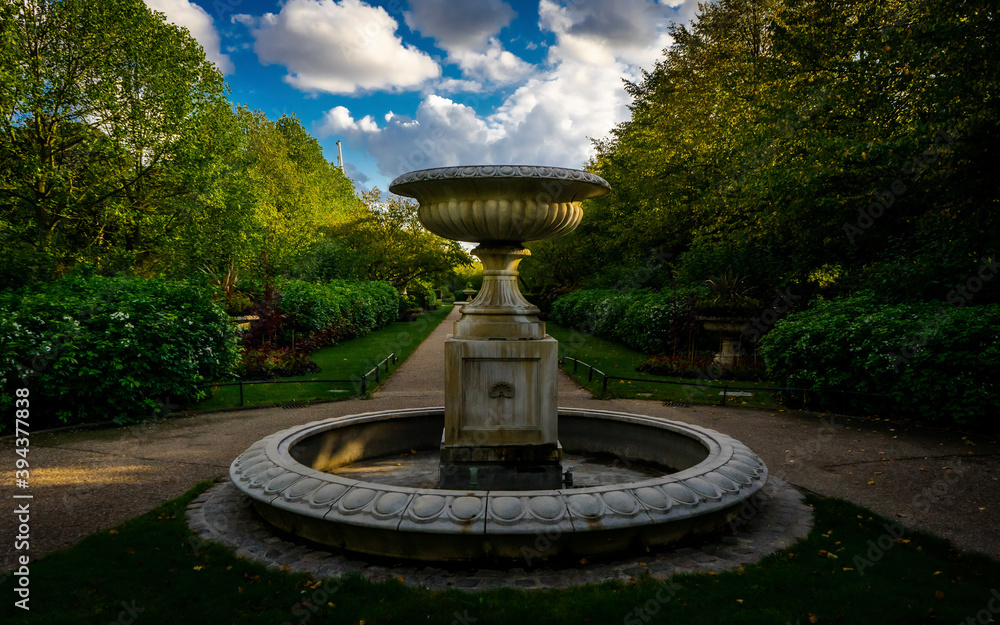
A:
[551, 289, 701, 354]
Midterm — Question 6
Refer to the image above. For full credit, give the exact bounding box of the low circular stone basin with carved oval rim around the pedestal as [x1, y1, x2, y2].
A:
[229, 408, 767, 561]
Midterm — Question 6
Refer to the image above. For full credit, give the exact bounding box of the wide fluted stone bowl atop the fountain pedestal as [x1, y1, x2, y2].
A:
[389, 165, 611, 244]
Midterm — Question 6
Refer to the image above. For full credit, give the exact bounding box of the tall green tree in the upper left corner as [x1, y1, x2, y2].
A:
[0, 0, 229, 282]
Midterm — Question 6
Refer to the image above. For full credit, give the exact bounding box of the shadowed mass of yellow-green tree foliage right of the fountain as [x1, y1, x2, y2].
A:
[525, 0, 1000, 303]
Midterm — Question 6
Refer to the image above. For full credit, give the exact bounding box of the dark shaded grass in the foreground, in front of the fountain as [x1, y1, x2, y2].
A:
[0, 482, 1000, 625]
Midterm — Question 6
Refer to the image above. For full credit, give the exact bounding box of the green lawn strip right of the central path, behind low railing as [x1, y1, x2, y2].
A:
[545, 321, 781, 409]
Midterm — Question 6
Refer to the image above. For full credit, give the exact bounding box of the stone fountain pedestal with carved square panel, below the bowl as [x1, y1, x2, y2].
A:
[440, 246, 562, 490]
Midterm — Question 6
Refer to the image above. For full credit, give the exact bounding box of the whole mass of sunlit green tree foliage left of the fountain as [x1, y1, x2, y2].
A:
[0, 0, 360, 285]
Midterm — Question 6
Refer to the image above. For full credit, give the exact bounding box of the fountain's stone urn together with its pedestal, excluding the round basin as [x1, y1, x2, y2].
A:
[389, 165, 611, 490]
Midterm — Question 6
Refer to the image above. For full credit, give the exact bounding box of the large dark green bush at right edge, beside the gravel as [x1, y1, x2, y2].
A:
[759, 296, 1000, 427]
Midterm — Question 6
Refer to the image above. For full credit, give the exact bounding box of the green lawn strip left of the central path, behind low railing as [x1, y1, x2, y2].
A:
[187, 304, 452, 411]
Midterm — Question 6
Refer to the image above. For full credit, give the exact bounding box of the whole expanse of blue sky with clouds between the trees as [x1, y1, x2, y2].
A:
[145, 0, 697, 190]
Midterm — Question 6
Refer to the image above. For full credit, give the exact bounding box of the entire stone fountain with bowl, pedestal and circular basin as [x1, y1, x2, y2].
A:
[230, 165, 767, 560]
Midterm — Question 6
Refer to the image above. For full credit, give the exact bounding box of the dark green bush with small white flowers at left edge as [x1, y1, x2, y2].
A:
[0, 276, 238, 428]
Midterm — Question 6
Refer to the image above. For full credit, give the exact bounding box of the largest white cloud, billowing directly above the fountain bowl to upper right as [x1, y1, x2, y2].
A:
[321, 0, 696, 179]
